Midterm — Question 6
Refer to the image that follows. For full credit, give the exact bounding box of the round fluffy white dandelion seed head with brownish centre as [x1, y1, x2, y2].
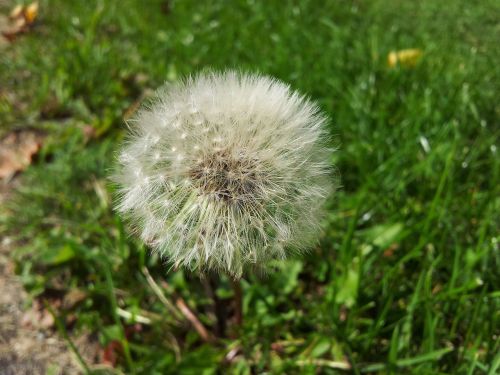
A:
[114, 71, 333, 276]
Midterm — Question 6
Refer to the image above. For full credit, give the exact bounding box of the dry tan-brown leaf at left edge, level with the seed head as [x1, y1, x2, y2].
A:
[0, 130, 42, 180]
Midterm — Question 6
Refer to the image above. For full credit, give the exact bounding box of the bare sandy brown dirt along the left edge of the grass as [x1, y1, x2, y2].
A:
[0, 0, 81, 375]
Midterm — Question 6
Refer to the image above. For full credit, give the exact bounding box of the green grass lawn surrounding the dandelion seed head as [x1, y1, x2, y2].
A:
[0, 0, 500, 374]
